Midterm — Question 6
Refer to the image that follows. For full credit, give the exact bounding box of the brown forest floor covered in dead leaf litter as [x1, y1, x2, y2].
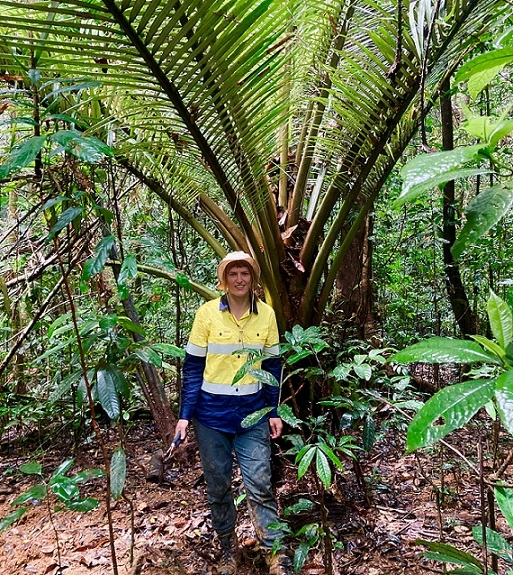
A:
[0, 408, 511, 575]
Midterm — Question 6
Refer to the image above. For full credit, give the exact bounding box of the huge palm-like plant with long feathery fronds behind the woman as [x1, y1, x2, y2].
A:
[0, 0, 503, 338]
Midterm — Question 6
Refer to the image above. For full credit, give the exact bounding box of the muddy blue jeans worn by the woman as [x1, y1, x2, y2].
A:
[194, 419, 282, 548]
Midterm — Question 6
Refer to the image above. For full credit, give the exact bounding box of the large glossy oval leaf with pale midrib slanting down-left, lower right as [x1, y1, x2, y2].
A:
[406, 379, 495, 452]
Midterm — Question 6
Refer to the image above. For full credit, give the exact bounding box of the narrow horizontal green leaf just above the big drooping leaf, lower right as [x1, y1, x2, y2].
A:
[389, 337, 500, 364]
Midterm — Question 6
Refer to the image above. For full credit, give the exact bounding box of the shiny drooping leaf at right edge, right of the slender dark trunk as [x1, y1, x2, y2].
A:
[451, 185, 513, 259]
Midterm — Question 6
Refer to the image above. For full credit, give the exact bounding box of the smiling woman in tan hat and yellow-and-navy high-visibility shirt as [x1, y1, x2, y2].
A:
[176, 252, 291, 575]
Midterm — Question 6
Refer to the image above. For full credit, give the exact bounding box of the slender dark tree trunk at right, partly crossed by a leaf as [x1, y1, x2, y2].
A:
[440, 80, 477, 335]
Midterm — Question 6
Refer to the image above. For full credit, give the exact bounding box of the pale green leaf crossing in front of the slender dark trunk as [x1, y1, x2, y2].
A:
[394, 144, 489, 206]
